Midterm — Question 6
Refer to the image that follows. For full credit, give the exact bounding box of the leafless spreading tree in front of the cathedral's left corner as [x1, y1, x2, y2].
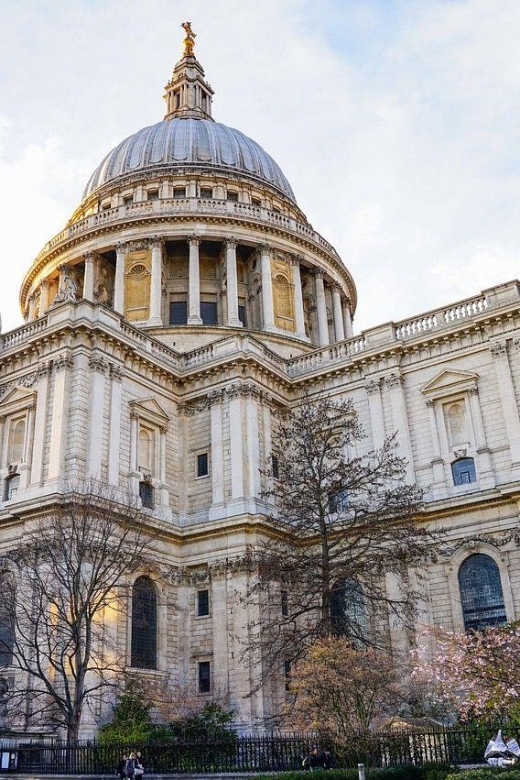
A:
[0, 483, 153, 744]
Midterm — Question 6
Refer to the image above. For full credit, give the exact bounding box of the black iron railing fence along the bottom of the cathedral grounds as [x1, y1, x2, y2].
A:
[0, 728, 510, 776]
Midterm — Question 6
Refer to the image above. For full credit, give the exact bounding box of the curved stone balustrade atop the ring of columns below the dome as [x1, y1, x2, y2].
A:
[31, 198, 339, 264]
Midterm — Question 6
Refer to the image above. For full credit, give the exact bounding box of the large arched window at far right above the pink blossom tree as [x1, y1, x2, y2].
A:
[459, 553, 507, 631]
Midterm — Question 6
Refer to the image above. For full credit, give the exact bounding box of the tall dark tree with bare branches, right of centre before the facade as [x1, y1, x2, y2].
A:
[247, 398, 432, 684]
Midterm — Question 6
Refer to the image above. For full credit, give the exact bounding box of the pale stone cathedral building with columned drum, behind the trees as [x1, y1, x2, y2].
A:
[0, 32, 520, 736]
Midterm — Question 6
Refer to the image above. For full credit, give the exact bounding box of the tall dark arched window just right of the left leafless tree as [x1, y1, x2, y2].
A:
[130, 577, 157, 669]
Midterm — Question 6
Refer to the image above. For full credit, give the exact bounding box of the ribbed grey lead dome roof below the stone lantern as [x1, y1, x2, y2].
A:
[83, 117, 296, 202]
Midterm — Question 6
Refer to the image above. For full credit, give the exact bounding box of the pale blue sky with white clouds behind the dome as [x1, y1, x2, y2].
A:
[0, 0, 520, 332]
